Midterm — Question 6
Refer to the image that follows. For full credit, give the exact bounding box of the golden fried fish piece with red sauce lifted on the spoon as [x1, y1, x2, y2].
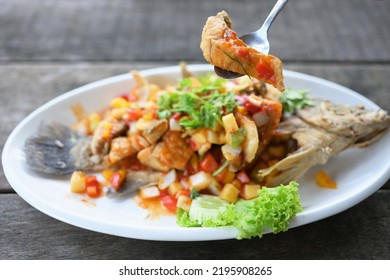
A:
[200, 11, 284, 91]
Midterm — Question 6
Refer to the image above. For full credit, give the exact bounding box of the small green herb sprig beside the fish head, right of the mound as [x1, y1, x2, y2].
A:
[279, 88, 314, 114]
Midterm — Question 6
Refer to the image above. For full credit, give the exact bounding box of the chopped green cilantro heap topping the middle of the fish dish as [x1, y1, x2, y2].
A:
[157, 75, 237, 130]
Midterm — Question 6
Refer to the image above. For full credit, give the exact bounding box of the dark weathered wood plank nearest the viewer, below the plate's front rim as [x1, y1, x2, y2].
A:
[0, 190, 390, 259]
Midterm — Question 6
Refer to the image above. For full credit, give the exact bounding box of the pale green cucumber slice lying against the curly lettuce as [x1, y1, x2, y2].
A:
[189, 195, 228, 224]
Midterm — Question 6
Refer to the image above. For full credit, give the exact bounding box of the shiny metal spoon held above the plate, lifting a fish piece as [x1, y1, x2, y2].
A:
[214, 0, 288, 79]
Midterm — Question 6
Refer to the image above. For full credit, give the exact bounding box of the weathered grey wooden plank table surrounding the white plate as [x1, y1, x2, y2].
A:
[0, 0, 390, 259]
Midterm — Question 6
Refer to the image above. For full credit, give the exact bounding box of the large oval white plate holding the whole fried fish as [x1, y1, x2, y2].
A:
[2, 65, 390, 241]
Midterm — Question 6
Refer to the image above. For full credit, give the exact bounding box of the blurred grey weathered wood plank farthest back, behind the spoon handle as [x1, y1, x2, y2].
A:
[0, 0, 390, 62]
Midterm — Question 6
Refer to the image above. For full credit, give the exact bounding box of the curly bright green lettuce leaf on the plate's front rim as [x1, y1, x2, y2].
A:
[177, 182, 302, 239]
